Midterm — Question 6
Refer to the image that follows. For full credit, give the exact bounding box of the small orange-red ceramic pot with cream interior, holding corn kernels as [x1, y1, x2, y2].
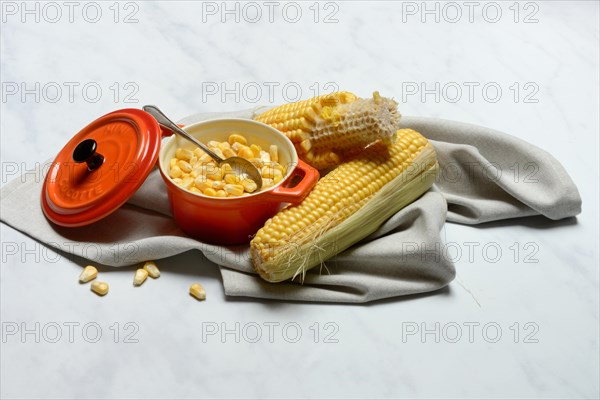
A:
[159, 119, 319, 244]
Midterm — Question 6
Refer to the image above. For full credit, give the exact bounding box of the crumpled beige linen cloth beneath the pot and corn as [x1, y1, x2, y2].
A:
[0, 110, 581, 303]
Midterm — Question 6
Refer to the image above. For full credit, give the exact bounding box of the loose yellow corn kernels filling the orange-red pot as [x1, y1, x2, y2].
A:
[169, 133, 286, 197]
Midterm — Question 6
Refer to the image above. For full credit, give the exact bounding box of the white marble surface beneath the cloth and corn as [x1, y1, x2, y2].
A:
[0, 1, 600, 398]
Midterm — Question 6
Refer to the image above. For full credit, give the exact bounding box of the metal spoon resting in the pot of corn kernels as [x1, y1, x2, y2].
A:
[143, 105, 262, 191]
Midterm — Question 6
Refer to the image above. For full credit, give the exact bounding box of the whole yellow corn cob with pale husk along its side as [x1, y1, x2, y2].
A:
[250, 129, 438, 282]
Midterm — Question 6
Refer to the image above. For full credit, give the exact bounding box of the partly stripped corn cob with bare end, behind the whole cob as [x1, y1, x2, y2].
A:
[255, 92, 400, 169]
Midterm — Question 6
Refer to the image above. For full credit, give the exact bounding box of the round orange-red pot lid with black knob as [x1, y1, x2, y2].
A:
[42, 109, 161, 227]
